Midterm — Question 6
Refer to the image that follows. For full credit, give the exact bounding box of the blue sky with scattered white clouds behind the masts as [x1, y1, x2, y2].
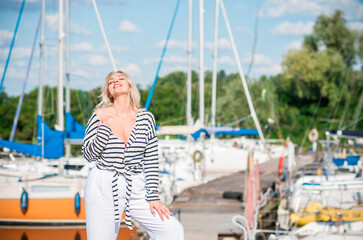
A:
[0, 0, 363, 96]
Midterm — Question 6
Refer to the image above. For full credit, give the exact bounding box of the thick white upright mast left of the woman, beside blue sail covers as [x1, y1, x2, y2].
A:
[56, 0, 64, 131]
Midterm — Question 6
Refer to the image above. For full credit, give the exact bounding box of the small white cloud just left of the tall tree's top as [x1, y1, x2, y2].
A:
[272, 21, 314, 36]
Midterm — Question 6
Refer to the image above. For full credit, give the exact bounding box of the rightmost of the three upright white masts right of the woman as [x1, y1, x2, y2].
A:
[211, 0, 219, 131]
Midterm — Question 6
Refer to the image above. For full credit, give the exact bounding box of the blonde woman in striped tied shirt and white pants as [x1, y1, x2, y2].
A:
[82, 71, 184, 240]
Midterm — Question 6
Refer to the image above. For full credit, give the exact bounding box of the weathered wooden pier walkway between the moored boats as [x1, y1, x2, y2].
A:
[169, 154, 314, 240]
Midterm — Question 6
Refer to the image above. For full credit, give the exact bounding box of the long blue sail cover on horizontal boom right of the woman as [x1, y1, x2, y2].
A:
[191, 127, 258, 140]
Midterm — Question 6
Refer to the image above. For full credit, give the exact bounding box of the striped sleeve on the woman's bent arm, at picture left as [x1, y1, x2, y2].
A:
[82, 113, 111, 162]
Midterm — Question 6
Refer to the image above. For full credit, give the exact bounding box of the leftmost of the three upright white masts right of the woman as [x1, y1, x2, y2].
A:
[186, 0, 193, 126]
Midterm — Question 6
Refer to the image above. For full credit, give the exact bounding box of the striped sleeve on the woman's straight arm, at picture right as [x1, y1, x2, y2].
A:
[144, 113, 160, 201]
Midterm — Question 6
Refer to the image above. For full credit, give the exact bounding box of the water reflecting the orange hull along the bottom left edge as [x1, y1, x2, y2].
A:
[0, 226, 139, 240]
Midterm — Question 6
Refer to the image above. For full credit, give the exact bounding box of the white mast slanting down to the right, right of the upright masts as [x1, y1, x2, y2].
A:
[220, 0, 265, 144]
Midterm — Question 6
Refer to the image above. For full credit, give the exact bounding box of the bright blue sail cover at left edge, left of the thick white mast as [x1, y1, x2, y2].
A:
[0, 116, 64, 159]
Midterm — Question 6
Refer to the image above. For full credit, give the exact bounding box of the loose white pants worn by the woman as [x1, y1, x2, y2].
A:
[84, 167, 184, 240]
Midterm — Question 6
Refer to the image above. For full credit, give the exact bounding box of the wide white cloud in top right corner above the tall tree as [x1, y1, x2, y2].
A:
[262, 0, 363, 19]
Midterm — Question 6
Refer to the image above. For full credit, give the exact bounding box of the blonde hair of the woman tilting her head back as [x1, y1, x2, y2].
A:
[95, 71, 140, 110]
